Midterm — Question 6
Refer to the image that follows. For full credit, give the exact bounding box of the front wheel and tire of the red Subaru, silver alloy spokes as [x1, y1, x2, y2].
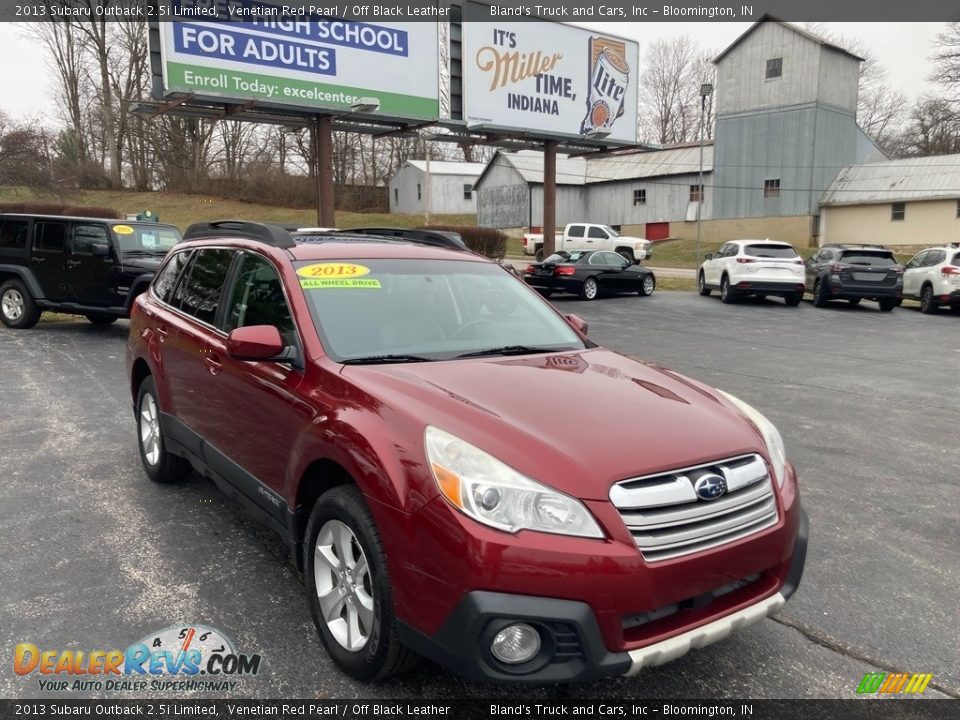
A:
[303, 485, 417, 681]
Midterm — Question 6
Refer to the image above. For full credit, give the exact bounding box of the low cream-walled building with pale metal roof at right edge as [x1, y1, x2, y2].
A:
[820, 155, 960, 245]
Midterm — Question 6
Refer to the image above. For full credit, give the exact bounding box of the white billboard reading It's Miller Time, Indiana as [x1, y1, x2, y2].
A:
[463, 20, 639, 143]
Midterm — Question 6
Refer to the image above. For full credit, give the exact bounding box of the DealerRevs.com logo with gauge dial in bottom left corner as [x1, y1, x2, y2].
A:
[13, 625, 261, 692]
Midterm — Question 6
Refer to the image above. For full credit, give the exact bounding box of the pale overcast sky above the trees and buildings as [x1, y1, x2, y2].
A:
[0, 22, 944, 125]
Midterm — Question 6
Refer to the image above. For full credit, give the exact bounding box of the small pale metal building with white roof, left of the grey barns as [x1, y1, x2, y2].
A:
[390, 160, 485, 214]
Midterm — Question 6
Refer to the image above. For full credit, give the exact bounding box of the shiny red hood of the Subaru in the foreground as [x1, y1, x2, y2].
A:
[342, 349, 766, 500]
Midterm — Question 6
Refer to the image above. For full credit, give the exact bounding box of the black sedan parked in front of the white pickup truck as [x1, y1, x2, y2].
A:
[523, 250, 657, 300]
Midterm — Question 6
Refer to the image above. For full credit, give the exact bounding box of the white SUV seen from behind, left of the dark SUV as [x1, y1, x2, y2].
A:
[697, 240, 803, 307]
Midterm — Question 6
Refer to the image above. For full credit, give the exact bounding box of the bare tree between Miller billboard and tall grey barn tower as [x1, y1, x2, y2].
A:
[638, 35, 714, 145]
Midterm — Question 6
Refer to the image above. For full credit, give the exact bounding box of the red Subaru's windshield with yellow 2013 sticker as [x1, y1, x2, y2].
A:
[296, 259, 586, 362]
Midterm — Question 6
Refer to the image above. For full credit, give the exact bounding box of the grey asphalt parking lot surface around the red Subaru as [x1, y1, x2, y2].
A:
[0, 292, 960, 700]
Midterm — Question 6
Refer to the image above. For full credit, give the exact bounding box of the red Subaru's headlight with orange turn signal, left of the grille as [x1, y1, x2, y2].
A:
[424, 426, 603, 538]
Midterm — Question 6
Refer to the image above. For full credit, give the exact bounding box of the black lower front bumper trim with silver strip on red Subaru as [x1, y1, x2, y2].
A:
[398, 500, 809, 683]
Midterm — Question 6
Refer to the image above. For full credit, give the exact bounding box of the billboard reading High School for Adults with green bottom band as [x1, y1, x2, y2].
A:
[159, 0, 440, 120]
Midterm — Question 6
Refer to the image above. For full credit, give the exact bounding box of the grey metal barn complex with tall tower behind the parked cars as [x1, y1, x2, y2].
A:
[477, 16, 884, 245]
